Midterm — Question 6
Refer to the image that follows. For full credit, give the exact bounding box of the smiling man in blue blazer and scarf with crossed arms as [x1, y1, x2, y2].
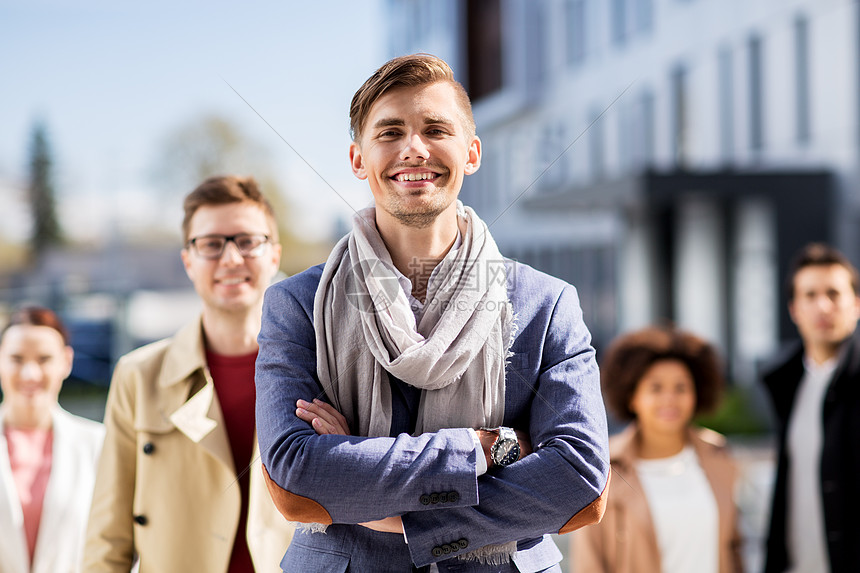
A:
[257, 54, 609, 573]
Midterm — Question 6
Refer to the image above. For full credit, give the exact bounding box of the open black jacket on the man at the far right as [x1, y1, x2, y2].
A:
[763, 332, 860, 573]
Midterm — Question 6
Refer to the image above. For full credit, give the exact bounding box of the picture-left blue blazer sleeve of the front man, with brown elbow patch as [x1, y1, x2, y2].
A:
[256, 275, 478, 525]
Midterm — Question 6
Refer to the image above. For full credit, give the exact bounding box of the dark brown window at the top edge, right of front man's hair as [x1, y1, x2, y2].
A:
[466, 0, 502, 101]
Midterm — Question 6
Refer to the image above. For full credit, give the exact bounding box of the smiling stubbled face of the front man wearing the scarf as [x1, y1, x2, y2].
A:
[349, 82, 481, 228]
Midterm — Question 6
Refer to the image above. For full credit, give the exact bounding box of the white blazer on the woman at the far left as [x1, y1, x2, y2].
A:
[0, 406, 104, 573]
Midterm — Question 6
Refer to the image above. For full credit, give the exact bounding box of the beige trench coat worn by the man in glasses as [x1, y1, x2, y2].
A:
[83, 320, 293, 573]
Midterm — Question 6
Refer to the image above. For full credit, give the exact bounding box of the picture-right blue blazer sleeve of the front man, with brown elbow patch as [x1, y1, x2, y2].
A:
[402, 285, 609, 566]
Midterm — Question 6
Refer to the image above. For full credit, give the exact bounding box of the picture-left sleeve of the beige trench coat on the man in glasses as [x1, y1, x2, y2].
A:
[83, 359, 136, 573]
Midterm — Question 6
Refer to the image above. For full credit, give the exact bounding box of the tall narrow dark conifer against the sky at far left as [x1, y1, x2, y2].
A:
[27, 122, 63, 257]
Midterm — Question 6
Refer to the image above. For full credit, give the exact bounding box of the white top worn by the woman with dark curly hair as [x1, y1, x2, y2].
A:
[636, 445, 719, 573]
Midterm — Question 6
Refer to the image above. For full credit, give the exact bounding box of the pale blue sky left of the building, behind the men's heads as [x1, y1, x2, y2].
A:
[0, 0, 388, 242]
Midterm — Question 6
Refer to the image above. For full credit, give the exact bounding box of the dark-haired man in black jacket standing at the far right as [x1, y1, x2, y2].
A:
[764, 244, 860, 573]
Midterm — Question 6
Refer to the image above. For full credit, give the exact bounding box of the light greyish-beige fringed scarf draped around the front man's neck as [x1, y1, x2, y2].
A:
[314, 201, 516, 564]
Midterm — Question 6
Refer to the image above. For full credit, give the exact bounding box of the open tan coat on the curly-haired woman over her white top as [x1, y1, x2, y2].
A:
[571, 423, 743, 573]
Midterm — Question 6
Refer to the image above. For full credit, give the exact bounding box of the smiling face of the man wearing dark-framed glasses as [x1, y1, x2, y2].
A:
[182, 203, 281, 312]
